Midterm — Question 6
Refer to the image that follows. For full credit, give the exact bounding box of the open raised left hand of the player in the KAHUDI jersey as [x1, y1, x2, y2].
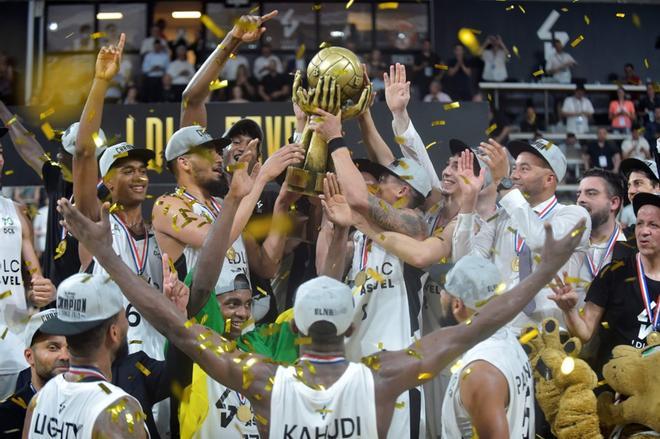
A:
[57, 198, 112, 249]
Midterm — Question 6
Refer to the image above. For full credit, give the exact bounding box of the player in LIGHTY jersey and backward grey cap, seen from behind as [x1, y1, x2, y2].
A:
[23, 276, 148, 438]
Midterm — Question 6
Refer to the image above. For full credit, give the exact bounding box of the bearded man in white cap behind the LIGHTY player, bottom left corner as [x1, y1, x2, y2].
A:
[0, 309, 69, 439]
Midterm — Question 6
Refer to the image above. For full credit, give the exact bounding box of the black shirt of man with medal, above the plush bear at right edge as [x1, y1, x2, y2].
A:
[586, 255, 660, 373]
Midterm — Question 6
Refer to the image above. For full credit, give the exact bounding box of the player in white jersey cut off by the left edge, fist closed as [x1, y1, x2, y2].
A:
[0, 145, 55, 400]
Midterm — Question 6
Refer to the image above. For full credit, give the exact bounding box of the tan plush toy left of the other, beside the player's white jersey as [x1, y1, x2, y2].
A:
[520, 318, 602, 439]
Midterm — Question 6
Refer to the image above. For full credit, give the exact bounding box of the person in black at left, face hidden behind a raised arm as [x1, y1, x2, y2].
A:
[0, 101, 107, 287]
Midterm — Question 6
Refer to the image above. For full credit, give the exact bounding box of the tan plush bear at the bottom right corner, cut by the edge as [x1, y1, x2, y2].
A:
[598, 332, 660, 439]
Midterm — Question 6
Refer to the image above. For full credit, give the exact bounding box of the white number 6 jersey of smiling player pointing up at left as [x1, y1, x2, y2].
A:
[92, 215, 165, 361]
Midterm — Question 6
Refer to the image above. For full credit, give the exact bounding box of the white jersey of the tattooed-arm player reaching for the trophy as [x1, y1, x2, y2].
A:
[346, 232, 426, 439]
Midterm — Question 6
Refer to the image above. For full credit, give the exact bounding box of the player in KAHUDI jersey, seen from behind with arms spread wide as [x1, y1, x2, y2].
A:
[59, 190, 584, 438]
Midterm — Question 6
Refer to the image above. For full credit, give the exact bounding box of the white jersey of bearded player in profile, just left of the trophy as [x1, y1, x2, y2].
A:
[183, 197, 250, 294]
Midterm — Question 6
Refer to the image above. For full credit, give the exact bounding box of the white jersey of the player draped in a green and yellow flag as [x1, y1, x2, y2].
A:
[193, 375, 259, 439]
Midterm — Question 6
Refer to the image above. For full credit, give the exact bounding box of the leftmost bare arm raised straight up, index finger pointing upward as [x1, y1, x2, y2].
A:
[73, 33, 126, 220]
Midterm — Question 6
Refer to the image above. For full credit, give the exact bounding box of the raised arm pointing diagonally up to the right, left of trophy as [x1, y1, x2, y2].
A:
[180, 11, 277, 128]
